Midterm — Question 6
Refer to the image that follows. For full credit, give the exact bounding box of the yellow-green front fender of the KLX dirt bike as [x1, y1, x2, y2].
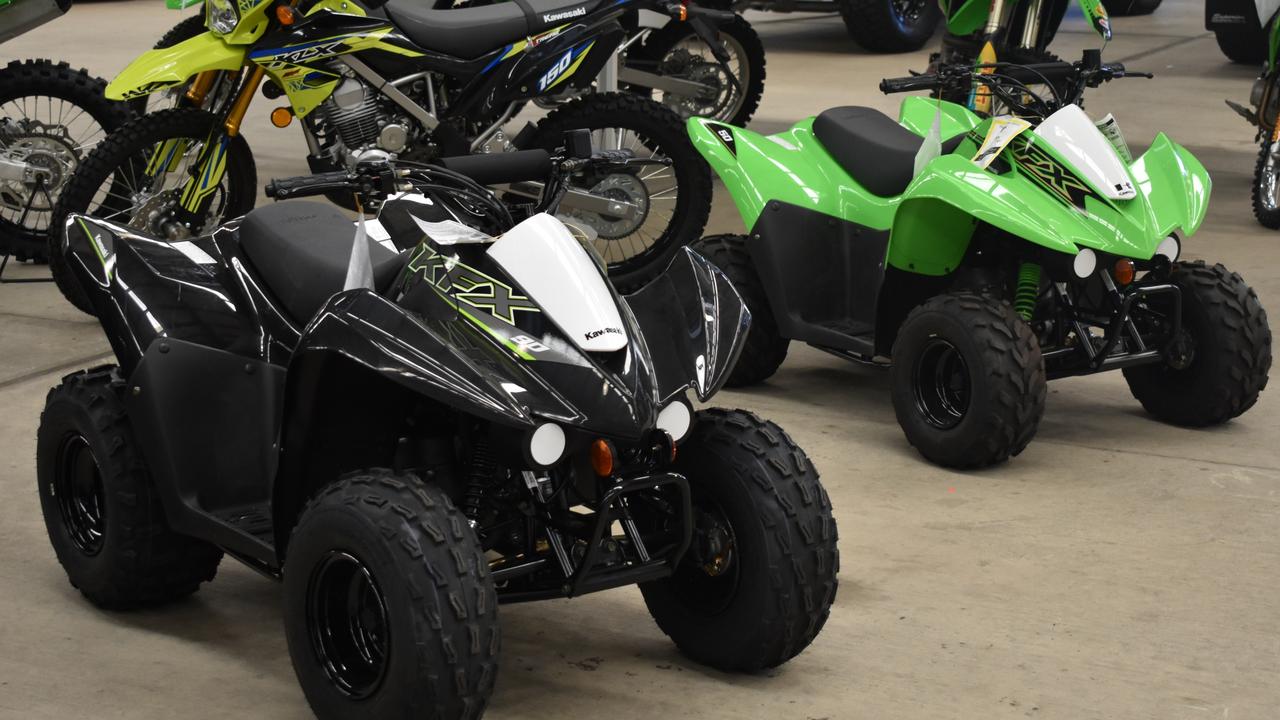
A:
[106, 32, 248, 100]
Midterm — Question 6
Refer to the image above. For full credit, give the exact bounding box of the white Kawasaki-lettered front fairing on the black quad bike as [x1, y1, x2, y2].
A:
[488, 213, 627, 352]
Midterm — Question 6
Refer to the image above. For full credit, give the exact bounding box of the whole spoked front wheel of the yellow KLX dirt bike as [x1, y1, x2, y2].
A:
[50, 108, 257, 313]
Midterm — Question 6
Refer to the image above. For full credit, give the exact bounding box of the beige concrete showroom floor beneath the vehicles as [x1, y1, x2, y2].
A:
[0, 0, 1280, 720]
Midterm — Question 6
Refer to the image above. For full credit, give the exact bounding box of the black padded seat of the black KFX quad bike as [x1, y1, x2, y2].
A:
[239, 201, 404, 323]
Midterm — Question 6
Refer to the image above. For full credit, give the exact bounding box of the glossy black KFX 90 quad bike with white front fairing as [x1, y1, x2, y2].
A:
[37, 144, 838, 719]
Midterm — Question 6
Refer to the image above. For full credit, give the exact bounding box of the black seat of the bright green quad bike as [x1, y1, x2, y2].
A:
[813, 105, 964, 197]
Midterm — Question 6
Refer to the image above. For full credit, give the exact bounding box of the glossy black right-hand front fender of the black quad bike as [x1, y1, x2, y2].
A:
[625, 247, 751, 401]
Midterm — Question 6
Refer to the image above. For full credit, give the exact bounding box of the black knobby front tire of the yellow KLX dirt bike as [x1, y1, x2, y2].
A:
[49, 108, 257, 315]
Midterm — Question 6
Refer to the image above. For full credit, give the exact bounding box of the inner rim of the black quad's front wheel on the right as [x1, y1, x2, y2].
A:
[673, 498, 742, 616]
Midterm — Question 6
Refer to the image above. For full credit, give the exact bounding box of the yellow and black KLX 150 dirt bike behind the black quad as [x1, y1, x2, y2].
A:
[54, 0, 710, 310]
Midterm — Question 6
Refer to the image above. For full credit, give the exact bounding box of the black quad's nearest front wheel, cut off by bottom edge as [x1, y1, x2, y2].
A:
[284, 470, 500, 720]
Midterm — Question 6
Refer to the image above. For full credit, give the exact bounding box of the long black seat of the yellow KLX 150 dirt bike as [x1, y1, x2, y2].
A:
[381, 0, 602, 60]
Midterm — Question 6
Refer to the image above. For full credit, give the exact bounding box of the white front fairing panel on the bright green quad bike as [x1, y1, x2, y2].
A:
[1036, 105, 1137, 200]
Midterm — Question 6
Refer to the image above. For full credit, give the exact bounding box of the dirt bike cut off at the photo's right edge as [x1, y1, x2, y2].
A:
[1219, 1, 1280, 224]
